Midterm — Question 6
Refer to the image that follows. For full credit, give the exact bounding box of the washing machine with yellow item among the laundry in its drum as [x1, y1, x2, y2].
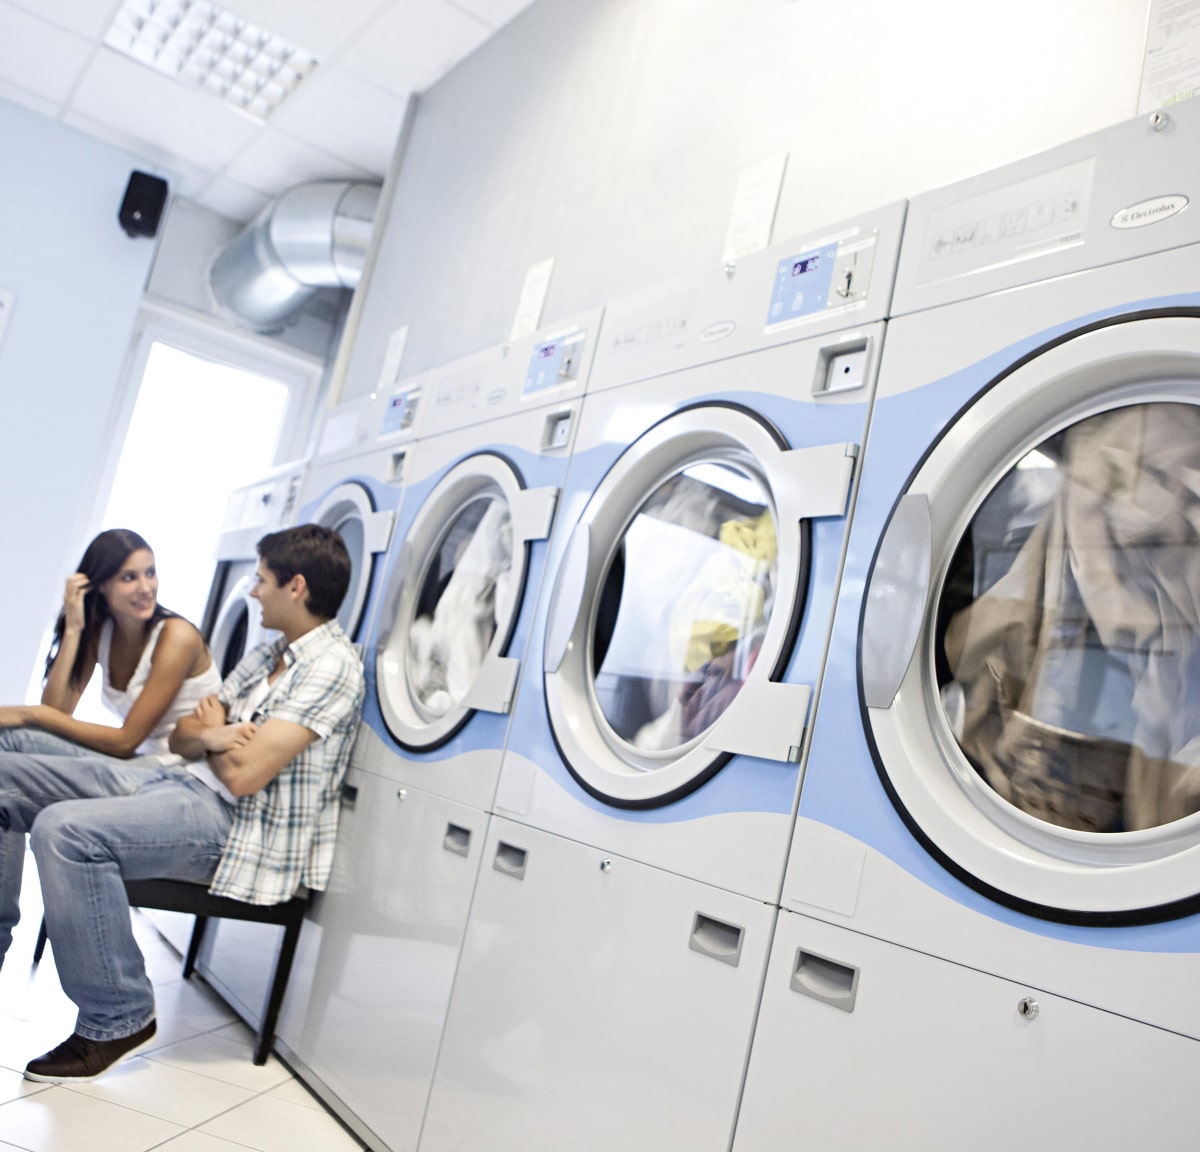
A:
[421, 204, 904, 1150]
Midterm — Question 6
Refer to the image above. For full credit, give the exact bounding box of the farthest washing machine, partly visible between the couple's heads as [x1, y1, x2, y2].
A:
[200, 461, 307, 679]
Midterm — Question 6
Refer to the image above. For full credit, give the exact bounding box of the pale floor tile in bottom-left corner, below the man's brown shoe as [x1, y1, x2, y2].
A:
[0, 1087, 184, 1152]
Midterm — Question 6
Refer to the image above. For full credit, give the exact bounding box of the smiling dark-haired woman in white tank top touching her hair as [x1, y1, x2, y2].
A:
[0, 528, 221, 760]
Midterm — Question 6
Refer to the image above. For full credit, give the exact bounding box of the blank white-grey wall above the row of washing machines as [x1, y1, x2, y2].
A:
[343, 0, 1150, 397]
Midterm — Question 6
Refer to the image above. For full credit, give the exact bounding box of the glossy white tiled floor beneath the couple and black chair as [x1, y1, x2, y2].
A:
[0, 860, 361, 1152]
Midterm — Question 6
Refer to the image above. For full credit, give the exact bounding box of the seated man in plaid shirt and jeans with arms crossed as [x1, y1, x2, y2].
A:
[0, 524, 364, 1084]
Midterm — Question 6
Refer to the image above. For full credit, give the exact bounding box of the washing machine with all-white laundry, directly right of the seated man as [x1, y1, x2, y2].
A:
[280, 310, 600, 1148]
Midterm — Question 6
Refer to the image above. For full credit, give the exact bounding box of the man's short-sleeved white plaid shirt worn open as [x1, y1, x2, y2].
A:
[209, 620, 365, 904]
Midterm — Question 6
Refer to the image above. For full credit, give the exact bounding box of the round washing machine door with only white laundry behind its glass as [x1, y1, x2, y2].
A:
[376, 452, 557, 751]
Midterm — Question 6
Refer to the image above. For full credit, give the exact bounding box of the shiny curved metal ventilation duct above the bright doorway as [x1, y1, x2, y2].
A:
[209, 180, 379, 331]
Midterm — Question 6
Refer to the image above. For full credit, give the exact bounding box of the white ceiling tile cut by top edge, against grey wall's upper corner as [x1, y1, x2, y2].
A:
[341, 0, 491, 96]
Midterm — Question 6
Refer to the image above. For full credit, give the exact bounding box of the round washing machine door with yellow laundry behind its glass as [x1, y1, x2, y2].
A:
[545, 404, 810, 808]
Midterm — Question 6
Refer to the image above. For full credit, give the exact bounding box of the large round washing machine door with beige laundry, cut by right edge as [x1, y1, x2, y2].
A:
[859, 314, 1200, 923]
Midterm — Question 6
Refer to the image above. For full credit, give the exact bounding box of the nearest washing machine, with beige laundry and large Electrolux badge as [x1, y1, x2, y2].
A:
[736, 102, 1200, 1150]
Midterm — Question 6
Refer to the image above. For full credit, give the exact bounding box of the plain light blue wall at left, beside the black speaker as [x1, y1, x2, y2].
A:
[0, 101, 158, 703]
